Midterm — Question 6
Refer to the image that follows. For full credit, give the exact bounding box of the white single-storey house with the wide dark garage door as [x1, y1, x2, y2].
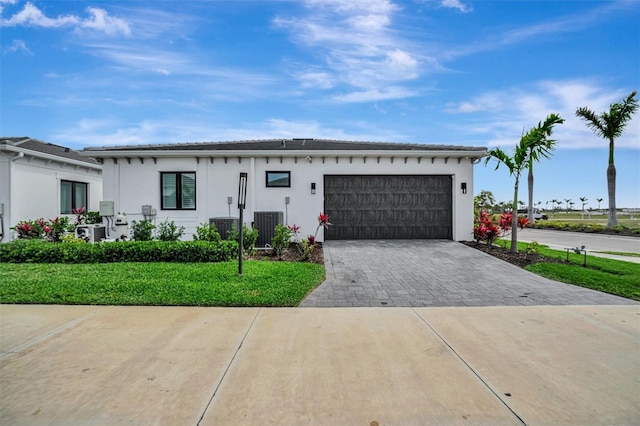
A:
[80, 139, 486, 245]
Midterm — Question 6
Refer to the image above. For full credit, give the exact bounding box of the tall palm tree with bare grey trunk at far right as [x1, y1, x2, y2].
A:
[576, 90, 638, 228]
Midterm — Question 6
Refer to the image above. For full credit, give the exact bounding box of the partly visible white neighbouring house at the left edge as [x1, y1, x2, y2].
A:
[0, 137, 102, 242]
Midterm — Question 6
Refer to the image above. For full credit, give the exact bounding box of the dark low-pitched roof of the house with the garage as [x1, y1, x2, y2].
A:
[83, 138, 487, 155]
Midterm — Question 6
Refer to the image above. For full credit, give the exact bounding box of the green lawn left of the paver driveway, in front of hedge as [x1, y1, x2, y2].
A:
[0, 261, 324, 306]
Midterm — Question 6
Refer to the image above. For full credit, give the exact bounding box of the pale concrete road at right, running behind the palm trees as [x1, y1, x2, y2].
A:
[518, 228, 640, 263]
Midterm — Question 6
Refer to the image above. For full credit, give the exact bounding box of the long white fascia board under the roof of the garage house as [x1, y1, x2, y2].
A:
[80, 150, 487, 158]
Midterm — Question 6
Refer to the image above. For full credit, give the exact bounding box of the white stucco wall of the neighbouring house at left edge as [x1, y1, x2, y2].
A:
[0, 152, 103, 242]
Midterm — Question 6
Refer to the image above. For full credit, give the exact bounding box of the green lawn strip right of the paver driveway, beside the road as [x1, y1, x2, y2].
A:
[518, 243, 640, 301]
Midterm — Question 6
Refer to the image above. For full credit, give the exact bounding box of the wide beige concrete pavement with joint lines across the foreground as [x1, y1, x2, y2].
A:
[0, 305, 640, 425]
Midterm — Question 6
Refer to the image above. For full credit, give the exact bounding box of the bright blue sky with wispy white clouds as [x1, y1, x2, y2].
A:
[0, 0, 640, 207]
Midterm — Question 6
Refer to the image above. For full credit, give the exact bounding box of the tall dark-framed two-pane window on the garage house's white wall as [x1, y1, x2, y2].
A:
[160, 172, 196, 210]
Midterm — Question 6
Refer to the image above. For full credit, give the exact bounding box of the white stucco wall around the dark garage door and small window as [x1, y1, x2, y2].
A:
[103, 153, 480, 241]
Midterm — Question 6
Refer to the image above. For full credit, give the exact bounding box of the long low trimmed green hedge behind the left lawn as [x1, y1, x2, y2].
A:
[0, 240, 238, 263]
